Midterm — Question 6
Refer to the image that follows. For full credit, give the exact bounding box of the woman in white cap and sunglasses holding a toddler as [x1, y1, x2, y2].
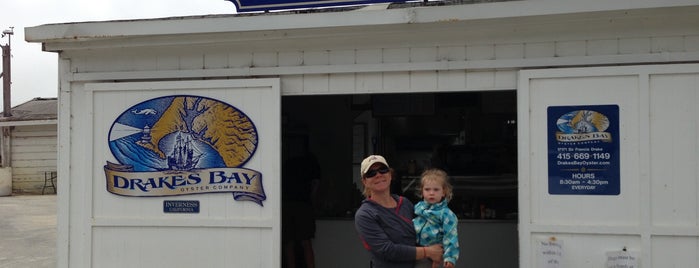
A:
[354, 155, 443, 268]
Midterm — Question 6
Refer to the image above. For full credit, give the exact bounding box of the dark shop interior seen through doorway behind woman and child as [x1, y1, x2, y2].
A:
[282, 90, 517, 220]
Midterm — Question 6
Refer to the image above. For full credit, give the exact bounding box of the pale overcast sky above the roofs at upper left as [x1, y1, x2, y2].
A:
[0, 0, 235, 107]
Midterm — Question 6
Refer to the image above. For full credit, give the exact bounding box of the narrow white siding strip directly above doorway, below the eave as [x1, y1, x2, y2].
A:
[65, 33, 699, 95]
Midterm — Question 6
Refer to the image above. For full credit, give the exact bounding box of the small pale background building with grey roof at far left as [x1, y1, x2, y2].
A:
[0, 98, 58, 194]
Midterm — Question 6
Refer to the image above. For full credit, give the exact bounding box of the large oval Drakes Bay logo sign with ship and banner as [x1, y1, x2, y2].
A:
[104, 95, 266, 205]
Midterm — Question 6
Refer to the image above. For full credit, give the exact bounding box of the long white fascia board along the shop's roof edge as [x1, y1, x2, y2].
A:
[25, 0, 697, 43]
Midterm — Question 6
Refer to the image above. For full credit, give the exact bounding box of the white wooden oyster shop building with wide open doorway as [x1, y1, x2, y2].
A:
[25, 0, 699, 268]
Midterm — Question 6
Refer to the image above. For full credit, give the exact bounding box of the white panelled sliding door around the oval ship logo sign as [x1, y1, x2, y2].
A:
[66, 79, 281, 267]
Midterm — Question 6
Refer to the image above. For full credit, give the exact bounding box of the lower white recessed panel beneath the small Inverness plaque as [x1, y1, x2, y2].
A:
[90, 227, 270, 268]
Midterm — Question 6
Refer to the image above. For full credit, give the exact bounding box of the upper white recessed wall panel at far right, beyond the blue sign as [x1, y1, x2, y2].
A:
[650, 74, 699, 227]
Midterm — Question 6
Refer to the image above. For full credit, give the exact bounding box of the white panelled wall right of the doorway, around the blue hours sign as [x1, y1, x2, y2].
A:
[518, 64, 699, 268]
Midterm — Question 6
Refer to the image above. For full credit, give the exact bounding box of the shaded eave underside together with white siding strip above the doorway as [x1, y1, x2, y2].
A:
[56, 8, 699, 95]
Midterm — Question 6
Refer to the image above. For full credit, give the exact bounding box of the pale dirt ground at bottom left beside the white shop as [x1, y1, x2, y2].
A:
[0, 195, 56, 268]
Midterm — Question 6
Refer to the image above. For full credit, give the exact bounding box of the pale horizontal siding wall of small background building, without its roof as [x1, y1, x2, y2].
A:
[11, 125, 58, 194]
